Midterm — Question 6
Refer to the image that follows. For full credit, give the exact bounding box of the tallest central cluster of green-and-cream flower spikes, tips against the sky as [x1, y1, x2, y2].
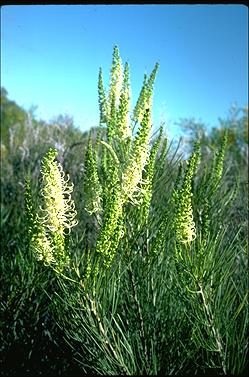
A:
[92, 46, 158, 266]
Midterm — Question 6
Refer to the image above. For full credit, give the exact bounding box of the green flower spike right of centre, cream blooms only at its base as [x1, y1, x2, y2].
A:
[174, 144, 200, 244]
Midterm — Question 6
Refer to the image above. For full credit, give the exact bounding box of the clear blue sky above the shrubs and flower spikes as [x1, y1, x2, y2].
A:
[1, 4, 248, 135]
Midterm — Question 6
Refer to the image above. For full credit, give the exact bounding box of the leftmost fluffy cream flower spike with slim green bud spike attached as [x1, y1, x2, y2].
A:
[26, 148, 77, 271]
